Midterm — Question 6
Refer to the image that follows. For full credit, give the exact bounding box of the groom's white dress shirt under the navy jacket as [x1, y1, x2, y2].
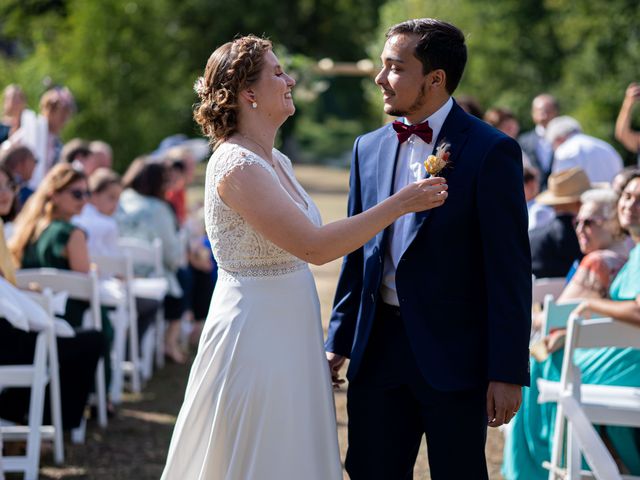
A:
[380, 98, 453, 306]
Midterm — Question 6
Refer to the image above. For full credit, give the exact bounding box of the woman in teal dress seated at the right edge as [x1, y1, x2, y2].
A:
[502, 171, 640, 480]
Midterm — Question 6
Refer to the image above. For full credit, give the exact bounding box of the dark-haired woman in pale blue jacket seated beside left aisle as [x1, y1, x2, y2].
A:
[116, 158, 186, 363]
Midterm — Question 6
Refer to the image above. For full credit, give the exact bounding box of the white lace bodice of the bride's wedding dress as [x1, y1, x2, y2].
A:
[204, 143, 321, 279]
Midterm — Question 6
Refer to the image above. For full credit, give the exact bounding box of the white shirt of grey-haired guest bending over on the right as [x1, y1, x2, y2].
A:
[553, 133, 623, 183]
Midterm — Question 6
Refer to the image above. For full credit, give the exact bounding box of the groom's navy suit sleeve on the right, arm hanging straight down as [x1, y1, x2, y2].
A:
[477, 137, 531, 385]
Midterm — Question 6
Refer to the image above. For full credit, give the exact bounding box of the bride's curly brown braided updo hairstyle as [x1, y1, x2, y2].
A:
[193, 35, 272, 148]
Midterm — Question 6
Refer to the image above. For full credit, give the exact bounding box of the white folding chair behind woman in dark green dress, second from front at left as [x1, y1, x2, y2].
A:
[16, 268, 107, 443]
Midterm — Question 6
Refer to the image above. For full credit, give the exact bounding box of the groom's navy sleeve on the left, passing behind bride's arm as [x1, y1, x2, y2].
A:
[325, 137, 363, 357]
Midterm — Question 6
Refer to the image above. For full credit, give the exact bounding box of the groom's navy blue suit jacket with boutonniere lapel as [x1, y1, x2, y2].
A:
[325, 103, 531, 390]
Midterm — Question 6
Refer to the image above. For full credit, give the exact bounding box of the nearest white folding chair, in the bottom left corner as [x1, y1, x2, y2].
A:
[0, 290, 64, 480]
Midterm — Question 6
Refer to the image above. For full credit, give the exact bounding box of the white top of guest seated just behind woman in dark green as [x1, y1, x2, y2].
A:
[71, 203, 119, 256]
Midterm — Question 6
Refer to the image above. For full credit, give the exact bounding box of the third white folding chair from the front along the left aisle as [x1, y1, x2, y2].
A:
[91, 254, 141, 404]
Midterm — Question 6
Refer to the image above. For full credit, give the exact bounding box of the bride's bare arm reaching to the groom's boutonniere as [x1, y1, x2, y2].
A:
[217, 165, 447, 265]
